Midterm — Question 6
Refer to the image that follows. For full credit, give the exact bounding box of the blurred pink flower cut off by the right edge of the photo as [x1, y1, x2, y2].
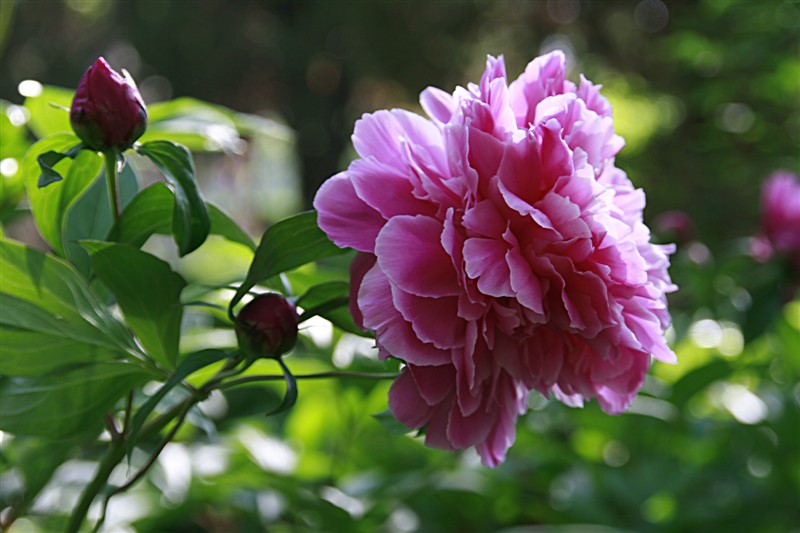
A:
[761, 170, 800, 259]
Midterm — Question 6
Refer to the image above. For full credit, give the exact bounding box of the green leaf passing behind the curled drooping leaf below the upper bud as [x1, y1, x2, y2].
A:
[111, 183, 256, 250]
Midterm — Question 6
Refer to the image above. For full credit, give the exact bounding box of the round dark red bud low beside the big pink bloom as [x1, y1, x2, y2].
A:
[236, 293, 298, 357]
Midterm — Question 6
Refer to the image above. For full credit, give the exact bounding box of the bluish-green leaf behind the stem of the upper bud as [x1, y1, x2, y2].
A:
[64, 160, 139, 279]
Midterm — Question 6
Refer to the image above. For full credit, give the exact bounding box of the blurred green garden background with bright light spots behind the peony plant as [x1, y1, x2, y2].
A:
[0, 0, 800, 533]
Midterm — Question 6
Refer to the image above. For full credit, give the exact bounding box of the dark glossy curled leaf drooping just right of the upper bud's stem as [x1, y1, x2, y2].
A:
[138, 141, 211, 256]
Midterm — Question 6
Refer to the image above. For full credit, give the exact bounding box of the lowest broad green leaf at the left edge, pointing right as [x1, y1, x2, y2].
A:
[0, 362, 148, 439]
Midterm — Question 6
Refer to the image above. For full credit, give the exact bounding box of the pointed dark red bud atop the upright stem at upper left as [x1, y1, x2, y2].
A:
[69, 57, 147, 150]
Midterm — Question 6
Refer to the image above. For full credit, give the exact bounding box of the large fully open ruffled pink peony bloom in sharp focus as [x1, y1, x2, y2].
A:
[314, 52, 675, 466]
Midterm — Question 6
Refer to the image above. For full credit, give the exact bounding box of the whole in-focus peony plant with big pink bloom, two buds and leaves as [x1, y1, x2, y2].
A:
[0, 52, 675, 532]
